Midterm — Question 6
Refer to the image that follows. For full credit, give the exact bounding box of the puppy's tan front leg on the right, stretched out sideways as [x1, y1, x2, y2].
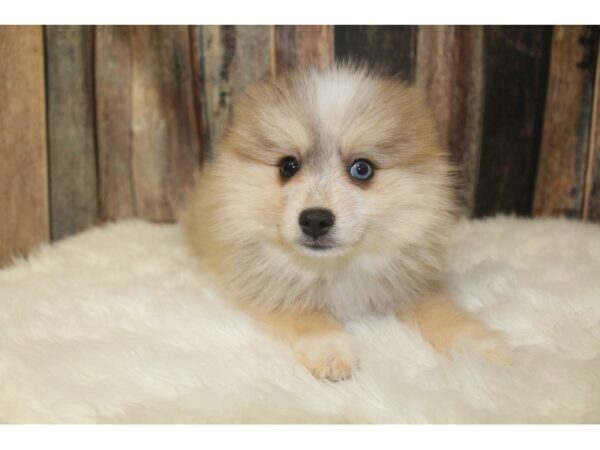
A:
[397, 292, 511, 364]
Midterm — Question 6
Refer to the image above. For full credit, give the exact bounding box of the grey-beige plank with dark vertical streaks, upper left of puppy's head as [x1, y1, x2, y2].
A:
[196, 25, 275, 157]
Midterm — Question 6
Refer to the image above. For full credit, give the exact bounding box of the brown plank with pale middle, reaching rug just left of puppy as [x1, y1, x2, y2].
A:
[131, 26, 200, 221]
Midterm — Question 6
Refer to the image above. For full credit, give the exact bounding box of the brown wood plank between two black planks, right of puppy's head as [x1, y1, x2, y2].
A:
[416, 26, 483, 214]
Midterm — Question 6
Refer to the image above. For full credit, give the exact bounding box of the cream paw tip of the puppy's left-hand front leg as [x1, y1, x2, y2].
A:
[292, 331, 358, 381]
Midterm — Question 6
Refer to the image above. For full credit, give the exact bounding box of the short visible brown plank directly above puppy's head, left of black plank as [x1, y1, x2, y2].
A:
[275, 25, 335, 74]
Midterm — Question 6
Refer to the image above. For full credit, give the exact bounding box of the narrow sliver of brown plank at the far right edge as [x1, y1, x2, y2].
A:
[583, 26, 600, 222]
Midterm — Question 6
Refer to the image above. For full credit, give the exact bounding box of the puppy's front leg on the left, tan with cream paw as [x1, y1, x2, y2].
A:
[247, 310, 358, 381]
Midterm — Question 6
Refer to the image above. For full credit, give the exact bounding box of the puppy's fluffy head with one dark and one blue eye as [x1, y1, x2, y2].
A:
[217, 66, 453, 258]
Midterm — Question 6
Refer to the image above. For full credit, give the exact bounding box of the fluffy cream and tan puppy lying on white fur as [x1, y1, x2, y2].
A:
[182, 65, 504, 380]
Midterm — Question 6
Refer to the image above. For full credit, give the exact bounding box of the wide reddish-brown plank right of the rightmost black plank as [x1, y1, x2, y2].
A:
[533, 26, 595, 218]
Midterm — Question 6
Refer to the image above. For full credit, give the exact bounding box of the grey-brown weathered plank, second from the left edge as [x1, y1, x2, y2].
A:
[45, 26, 98, 240]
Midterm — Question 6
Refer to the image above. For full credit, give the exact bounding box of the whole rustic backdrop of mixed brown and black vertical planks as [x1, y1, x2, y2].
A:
[0, 26, 600, 264]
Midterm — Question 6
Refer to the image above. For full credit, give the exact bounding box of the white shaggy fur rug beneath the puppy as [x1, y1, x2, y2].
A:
[0, 218, 600, 423]
